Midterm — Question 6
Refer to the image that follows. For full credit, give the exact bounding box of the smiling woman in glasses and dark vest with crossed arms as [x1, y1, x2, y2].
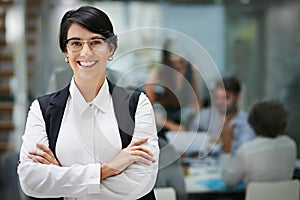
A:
[18, 6, 159, 200]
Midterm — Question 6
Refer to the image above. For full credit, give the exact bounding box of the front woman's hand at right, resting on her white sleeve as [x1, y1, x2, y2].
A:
[102, 138, 155, 179]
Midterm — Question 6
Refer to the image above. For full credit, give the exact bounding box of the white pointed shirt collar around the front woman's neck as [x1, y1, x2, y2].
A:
[69, 78, 110, 115]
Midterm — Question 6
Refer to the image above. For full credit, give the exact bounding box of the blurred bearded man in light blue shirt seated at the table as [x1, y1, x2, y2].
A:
[191, 77, 255, 155]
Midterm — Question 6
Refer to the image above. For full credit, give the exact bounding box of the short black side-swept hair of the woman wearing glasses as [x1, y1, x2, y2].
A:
[59, 6, 117, 52]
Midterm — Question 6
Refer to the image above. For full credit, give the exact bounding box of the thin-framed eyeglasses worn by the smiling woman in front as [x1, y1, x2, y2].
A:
[65, 38, 109, 52]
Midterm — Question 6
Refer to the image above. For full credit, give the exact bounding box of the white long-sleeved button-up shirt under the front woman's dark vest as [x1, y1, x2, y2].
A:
[18, 80, 159, 200]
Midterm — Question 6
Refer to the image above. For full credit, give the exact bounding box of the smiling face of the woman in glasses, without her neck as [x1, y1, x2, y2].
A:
[66, 23, 113, 81]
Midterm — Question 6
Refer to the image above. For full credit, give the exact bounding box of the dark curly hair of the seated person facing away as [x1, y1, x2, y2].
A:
[248, 100, 288, 138]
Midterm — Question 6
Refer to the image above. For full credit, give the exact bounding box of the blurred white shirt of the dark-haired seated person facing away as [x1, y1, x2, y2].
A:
[221, 135, 297, 185]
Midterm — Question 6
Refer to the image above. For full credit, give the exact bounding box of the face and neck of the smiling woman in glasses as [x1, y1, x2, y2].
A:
[64, 22, 115, 98]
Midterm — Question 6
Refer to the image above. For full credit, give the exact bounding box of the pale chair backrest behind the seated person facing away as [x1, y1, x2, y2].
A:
[246, 180, 300, 200]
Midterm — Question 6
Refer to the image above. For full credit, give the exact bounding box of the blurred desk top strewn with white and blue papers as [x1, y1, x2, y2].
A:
[185, 162, 245, 200]
